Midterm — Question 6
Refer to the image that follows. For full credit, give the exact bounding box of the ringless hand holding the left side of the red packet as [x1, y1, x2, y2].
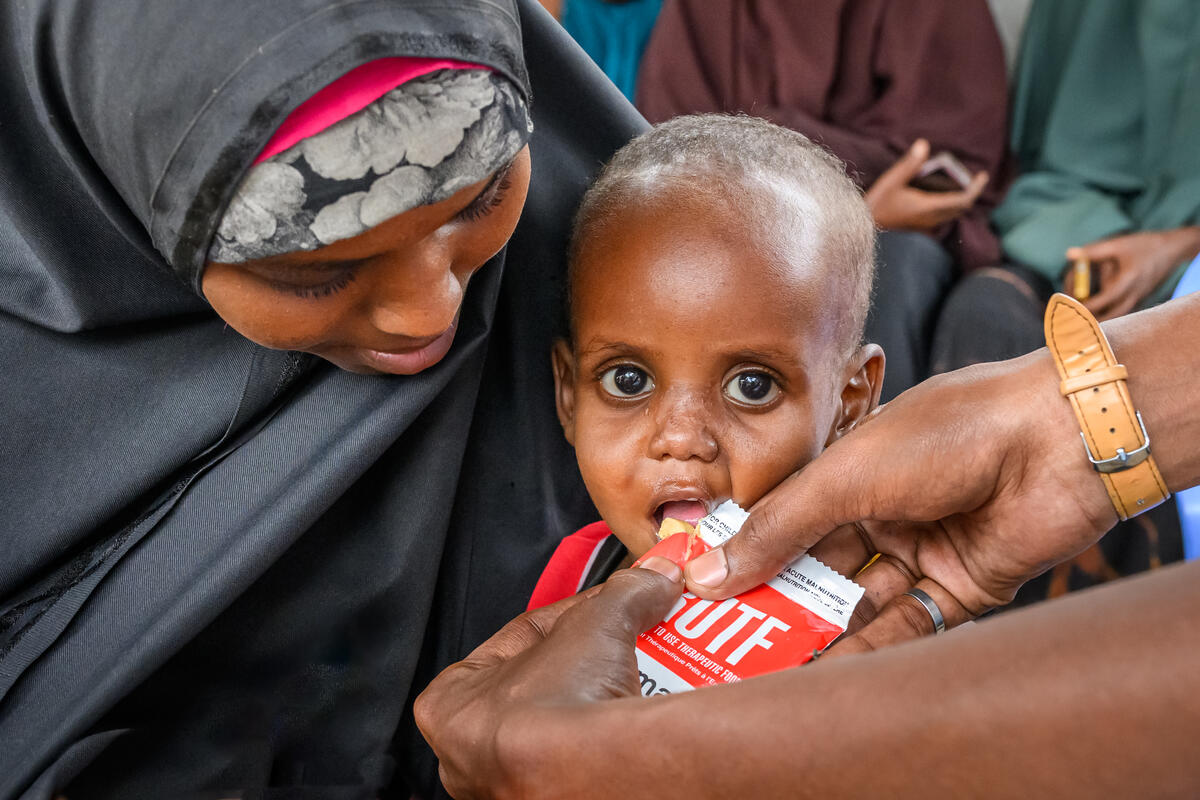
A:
[413, 558, 683, 798]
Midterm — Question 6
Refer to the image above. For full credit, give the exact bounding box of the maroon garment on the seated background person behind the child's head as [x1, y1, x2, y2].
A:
[637, 0, 1008, 269]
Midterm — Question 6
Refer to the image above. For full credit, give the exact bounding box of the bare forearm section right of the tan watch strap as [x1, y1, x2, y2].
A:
[1104, 294, 1200, 492]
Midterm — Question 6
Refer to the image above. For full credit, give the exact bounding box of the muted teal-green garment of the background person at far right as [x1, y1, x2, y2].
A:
[992, 0, 1200, 287]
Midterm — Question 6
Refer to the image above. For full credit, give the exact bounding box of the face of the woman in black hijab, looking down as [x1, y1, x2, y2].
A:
[202, 146, 529, 375]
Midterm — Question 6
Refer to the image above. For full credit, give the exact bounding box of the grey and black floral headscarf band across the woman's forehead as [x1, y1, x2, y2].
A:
[209, 67, 533, 263]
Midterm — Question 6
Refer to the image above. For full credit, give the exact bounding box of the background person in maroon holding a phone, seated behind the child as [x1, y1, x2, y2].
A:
[637, 0, 1008, 399]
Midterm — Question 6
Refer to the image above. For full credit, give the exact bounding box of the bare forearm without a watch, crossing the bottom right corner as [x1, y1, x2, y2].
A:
[530, 564, 1200, 800]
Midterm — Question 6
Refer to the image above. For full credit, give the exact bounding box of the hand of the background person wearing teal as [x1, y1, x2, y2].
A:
[1064, 227, 1200, 319]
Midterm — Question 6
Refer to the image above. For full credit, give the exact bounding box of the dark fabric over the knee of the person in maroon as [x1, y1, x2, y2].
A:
[864, 230, 954, 403]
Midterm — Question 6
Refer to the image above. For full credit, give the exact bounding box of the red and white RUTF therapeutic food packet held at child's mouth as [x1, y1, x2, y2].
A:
[637, 500, 863, 697]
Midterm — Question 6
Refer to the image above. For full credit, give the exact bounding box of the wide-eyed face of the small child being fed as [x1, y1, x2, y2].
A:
[553, 195, 883, 555]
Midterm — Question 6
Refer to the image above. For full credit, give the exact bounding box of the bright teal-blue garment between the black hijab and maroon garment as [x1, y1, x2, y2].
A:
[563, 0, 662, 102]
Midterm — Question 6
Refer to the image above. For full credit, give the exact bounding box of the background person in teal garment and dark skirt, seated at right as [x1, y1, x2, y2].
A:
[931, 0, 1200, 602]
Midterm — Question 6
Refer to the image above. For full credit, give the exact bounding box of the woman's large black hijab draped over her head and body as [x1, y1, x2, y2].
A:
[0, 0, 642, 798]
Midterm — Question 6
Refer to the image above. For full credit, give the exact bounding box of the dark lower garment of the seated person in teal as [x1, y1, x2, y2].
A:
[932, 265, 1183, 609]
